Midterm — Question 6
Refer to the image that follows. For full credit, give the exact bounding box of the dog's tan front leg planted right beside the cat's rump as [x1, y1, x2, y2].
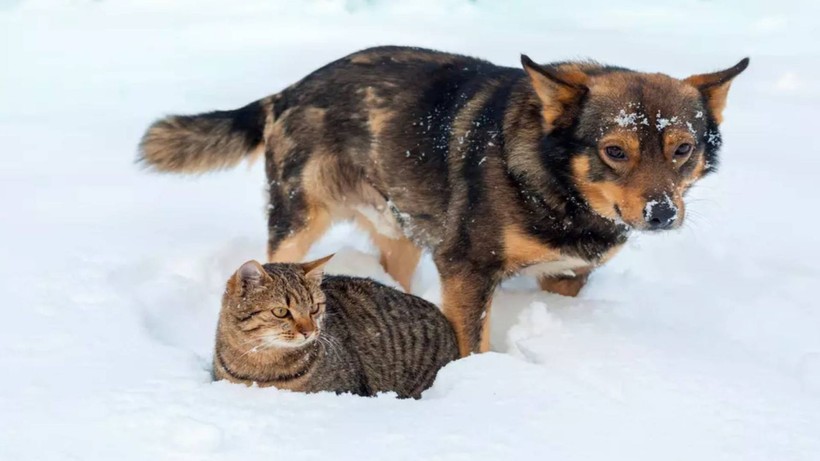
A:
[441, 267, 498, 357]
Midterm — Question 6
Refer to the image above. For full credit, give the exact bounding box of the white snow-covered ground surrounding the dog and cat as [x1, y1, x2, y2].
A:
[0, 0, 820, 461]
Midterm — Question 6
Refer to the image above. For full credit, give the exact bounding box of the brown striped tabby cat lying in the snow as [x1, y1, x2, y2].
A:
[213, 255, 459, 398]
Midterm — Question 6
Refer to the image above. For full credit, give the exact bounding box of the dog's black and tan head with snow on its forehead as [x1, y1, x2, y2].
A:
[521, 56, 749, 230]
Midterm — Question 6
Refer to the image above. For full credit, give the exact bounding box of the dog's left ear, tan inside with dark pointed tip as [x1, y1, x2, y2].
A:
[521, 54, 589, 131]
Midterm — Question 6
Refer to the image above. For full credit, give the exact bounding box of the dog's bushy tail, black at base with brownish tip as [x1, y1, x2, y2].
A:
[137, 97, 274, 174]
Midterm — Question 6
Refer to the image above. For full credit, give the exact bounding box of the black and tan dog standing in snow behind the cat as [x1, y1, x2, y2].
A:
[140, 47, 749, 355]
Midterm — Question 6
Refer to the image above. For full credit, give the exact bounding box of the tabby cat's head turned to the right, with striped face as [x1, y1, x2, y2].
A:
[220, 255, 333, 350]
